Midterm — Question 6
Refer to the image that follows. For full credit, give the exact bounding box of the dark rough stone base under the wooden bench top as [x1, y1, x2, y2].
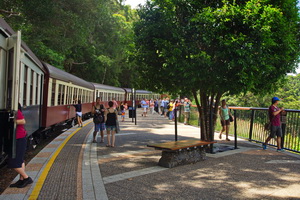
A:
[158, 147, 206, 168]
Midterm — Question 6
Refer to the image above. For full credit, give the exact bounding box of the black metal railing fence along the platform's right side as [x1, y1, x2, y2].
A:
[179, 106, 300, 153]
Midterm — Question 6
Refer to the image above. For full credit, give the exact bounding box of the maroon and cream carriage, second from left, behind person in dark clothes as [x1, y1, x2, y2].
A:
[42, 63, 94, 127]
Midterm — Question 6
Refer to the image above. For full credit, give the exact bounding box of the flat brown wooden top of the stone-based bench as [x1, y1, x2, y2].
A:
[147, 140, 216, 150]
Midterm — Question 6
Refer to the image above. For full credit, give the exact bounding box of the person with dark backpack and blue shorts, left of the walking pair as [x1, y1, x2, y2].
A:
[92, 97, 105, 143]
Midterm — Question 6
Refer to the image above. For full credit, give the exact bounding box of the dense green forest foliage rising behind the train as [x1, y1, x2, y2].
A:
[0, 0, 138, 87]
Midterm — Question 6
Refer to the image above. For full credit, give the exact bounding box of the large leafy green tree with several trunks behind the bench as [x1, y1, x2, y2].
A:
[135, 0, 300, 140]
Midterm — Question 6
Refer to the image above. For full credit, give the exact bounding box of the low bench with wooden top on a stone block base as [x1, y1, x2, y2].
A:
[147, 140, 216, 168]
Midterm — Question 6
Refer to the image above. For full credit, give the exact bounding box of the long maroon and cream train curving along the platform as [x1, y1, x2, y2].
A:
[0, 18, 160, 163]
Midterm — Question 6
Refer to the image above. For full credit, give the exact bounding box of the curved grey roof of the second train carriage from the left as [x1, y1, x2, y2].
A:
[44, 62, 94, 90]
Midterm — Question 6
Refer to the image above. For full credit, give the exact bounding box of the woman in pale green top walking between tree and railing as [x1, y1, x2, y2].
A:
[219, 99, 233, 141]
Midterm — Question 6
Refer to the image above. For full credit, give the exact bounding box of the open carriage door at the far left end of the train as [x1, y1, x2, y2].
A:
[1, 31, 21, 157]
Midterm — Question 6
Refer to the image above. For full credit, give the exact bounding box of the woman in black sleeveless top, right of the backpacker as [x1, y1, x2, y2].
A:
[105, 101, 118, 147]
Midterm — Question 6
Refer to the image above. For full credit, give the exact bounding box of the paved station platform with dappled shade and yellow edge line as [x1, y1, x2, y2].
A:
[0, 110, 300, 200]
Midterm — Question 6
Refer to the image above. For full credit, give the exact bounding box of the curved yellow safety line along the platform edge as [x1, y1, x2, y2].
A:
[28, 121, 92, 200]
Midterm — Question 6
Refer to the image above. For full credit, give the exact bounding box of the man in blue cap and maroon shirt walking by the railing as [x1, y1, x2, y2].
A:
[262, 97, 284, 152]
